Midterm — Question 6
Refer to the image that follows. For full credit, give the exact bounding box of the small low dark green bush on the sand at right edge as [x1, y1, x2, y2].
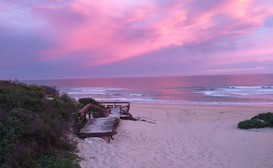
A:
[238, 112, 273, 129]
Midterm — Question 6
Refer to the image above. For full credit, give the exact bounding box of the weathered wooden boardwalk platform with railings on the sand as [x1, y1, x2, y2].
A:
[78, 102, 132, 142]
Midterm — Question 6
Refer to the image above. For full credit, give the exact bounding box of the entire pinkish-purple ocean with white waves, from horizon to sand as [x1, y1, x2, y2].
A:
[24, 74, 273, 105]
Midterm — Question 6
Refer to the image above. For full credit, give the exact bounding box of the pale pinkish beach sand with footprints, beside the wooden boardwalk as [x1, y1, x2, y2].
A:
[74, 104, 273, 168]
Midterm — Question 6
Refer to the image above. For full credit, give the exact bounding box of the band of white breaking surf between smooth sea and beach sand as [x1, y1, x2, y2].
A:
[59, 86, 273, 105]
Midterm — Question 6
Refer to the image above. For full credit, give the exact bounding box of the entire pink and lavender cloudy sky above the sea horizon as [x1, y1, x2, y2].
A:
[0, 0, 273, 80]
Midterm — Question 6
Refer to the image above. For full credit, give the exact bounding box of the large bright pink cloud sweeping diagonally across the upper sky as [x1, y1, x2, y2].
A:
[31, 0, 273, 65]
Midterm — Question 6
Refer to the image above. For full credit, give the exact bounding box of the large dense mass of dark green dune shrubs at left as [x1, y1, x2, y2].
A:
[0, 81, 80, 168]
